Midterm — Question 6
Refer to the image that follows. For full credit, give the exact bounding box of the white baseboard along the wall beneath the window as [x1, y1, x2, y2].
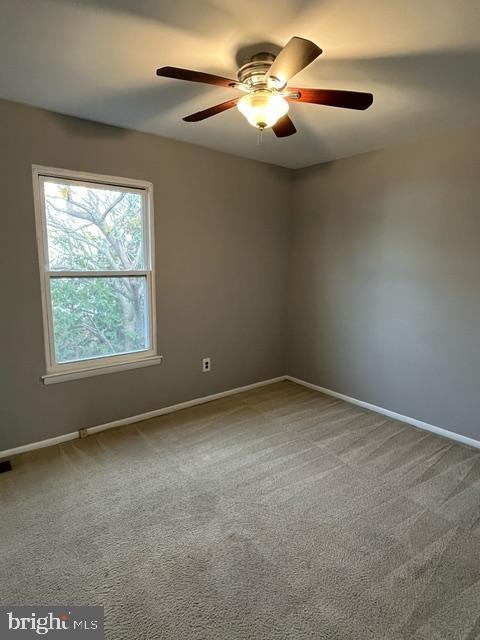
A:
[0, 376, 286, 460]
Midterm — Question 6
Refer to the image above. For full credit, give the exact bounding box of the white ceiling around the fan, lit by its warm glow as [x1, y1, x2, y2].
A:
[0, 0, 480, 168]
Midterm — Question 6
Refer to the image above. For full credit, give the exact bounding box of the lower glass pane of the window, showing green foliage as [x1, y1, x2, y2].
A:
[50, 276, 150, 363]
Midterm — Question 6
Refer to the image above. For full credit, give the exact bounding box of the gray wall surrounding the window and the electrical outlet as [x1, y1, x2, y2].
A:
[0, 101, 291, 450]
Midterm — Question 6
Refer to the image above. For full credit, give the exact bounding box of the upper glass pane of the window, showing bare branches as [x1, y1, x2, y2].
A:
[44, 180, 145, 271]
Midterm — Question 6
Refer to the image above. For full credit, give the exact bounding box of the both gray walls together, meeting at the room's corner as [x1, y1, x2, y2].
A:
[0, 101, 480, 450]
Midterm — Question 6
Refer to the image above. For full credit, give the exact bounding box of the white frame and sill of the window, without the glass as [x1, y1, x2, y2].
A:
[32, 165, 162, 384]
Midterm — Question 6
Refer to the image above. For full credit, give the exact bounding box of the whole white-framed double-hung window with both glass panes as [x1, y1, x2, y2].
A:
[33, 167, 160, 383]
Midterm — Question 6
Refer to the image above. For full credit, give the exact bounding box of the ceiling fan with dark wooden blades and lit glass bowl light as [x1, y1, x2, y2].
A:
[157, 36, 373, 138]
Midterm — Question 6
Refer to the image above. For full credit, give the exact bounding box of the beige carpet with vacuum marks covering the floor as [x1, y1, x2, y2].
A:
[0, 382, 480, 640]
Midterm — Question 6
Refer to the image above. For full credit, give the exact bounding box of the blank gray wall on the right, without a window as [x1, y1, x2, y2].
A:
[288, 129, 480, 439]
